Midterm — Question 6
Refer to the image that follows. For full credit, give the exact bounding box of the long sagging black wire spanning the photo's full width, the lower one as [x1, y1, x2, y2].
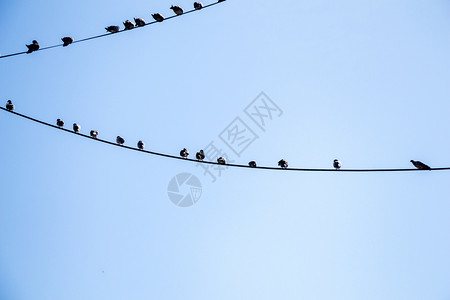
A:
[0, 107, 450, 172]
